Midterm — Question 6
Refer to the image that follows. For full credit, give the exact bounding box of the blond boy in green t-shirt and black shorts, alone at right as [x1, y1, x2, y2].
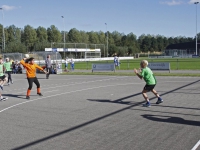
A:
[134, 60, 163, 107]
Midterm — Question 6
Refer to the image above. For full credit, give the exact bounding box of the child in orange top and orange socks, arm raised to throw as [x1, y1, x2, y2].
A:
[20, 57, 47, 99]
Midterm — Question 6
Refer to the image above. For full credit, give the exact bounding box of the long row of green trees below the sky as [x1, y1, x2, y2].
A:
[0, 24, 197, 56]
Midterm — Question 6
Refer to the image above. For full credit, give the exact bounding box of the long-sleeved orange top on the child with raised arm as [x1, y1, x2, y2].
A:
[20, 60, 44, 78]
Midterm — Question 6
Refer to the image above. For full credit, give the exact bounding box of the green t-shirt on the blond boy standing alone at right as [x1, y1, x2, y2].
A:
[141, 67, 156, 85]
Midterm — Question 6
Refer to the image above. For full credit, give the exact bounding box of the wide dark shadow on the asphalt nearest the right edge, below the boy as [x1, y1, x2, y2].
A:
[142, 115, 200, 126]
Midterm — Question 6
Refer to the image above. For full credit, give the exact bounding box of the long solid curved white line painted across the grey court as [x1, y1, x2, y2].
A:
[0, 83, 142, 113]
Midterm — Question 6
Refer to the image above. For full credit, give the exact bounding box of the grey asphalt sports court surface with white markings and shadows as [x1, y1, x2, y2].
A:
[0, 74, 200, 150]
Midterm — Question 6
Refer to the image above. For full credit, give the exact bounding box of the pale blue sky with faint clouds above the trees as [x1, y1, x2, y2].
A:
[0, 0, 200, 37]
